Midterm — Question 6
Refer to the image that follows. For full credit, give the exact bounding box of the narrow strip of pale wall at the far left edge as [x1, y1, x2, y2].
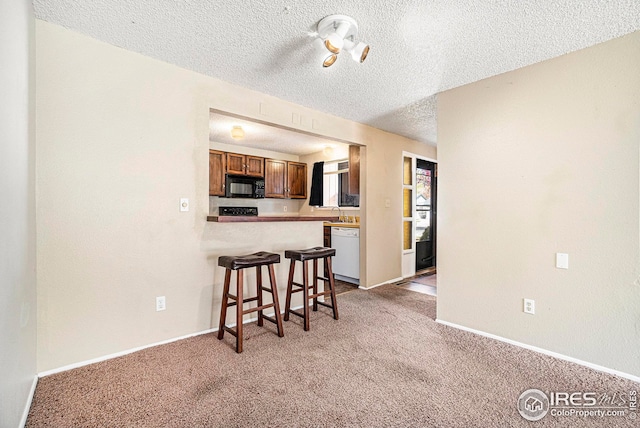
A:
[0, 0, 36, 427]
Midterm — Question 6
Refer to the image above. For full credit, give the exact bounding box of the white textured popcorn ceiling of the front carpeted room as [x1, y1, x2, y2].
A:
[33, 0, 640, 144]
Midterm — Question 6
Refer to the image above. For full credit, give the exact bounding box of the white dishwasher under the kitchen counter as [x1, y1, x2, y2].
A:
[331, 227, 360, 285]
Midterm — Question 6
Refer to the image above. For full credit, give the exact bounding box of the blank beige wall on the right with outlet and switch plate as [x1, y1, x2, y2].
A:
[438, 33, 640, 376]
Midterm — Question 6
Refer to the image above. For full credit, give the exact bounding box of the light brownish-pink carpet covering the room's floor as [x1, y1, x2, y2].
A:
[27, 285, 640, 427]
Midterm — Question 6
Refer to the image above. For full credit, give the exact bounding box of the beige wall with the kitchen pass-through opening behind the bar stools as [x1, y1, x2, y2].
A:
[36, 21, 435, 371]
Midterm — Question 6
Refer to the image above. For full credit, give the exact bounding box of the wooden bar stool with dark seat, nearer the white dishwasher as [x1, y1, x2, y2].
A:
[284, 247, 338, 330]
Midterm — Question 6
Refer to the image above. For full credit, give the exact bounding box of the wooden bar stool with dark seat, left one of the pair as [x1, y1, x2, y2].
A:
[218, 251, 284, 353]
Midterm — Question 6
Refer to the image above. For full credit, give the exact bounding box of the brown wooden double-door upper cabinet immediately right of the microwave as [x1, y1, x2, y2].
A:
[264, 159, 307, 199]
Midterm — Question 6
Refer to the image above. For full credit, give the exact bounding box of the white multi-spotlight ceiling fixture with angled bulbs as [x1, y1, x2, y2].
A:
[318, 15, 369, 67]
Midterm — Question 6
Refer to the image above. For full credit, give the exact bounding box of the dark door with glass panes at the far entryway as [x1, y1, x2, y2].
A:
[415, 159, 437, 271]
